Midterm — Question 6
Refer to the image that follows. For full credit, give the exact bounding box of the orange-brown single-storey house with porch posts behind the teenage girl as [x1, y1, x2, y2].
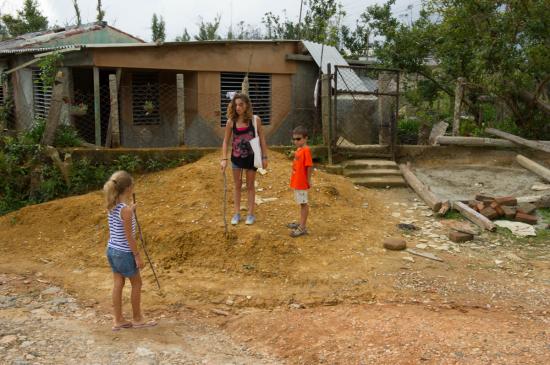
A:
[0, 33, 376, 147]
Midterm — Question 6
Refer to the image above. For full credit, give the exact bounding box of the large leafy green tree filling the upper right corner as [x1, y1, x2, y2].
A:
[367, 0, 550, 134]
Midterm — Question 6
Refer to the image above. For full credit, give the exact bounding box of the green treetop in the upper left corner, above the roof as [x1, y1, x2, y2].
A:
[2, 0, 48, 37]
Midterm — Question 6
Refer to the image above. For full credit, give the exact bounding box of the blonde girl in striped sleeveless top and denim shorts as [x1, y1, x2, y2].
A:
[103, 171, 156, 331]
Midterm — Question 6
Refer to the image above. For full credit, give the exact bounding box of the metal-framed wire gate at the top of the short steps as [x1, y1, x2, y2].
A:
[330, 65, 400, 160]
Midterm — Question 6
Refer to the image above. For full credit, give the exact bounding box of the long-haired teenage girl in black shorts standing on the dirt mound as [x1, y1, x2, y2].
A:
[221, 93, 267, 225]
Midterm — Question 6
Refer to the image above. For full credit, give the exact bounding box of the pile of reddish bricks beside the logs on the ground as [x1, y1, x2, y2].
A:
[468, 194, 538, 224]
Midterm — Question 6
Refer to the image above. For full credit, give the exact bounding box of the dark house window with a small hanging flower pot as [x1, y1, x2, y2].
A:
[132, 72, 160, 125]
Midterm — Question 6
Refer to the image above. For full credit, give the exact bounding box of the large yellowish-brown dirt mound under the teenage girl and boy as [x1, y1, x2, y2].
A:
[0, 152, 395, 306]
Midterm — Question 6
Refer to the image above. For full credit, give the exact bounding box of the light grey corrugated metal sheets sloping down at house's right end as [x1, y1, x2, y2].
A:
[302, 41, 374, 91]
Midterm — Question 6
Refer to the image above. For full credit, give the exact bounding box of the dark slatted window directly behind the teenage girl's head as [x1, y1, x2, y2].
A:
[220, 72, 271, 127]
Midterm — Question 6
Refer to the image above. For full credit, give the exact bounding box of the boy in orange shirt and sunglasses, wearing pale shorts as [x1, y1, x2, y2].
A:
[287, 126, 313, 237]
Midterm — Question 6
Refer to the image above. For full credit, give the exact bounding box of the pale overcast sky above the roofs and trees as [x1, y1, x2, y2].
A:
[0, 0, 420, 41]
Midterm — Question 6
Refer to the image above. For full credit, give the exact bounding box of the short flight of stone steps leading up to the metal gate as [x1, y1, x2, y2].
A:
[342, 159, 407, 188]
